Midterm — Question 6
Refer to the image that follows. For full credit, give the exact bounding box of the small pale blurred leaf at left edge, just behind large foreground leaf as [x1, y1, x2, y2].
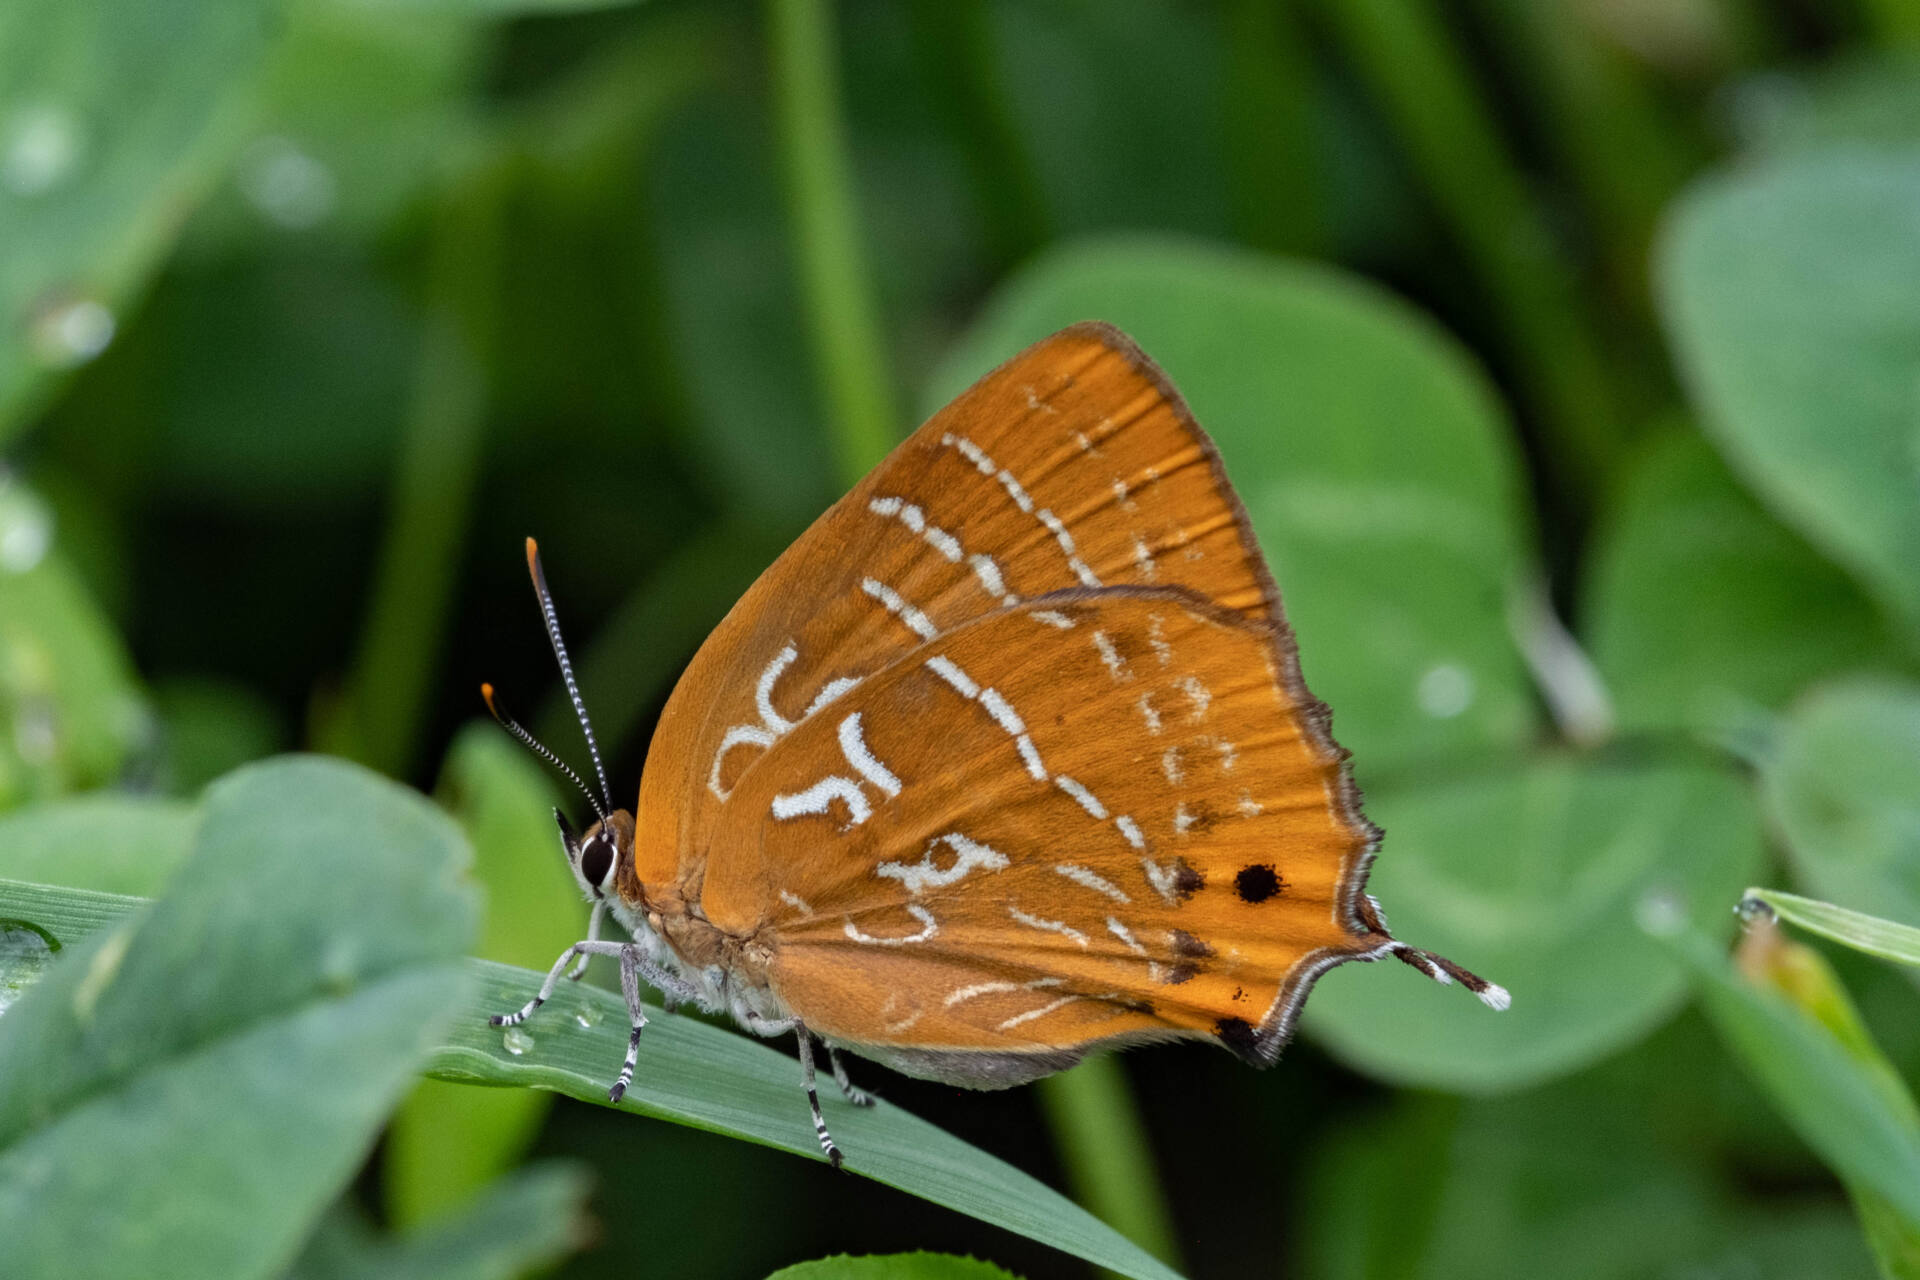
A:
[0, 791, 198, 898]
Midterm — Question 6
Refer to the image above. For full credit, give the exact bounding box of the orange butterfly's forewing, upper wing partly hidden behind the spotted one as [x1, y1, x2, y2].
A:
[624, 324, 1313, 890]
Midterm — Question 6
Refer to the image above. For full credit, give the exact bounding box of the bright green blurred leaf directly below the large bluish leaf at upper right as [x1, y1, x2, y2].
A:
[1580, 432, 1903, 735]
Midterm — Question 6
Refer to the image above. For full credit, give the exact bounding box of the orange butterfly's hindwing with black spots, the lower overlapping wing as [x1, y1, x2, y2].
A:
[703, 587, 1382, 1082]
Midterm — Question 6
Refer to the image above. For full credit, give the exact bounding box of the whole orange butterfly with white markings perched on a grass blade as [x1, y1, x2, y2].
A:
[482, 324, 1507, 1165]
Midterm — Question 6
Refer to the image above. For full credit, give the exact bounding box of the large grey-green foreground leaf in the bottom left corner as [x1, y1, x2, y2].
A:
[0, 758, 472, 1280]
